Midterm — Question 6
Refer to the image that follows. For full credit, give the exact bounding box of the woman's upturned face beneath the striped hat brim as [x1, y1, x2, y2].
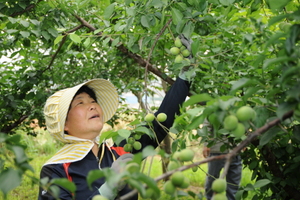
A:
[64, 92, 104, 140]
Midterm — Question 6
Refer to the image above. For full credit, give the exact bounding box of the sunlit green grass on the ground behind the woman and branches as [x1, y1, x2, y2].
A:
[0, 131, 253, 200]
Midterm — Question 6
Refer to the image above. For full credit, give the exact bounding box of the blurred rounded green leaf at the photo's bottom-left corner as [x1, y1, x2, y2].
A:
[0, 168, 21, 194]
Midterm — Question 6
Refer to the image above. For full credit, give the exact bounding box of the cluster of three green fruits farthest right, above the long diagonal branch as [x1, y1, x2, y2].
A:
[223, 106, 256, 138]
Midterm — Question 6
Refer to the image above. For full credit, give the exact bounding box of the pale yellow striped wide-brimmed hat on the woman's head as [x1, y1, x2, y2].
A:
[44, 79, 119, 142]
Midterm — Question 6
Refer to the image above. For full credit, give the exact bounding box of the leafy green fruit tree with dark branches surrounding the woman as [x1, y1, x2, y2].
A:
[0, 0, 300, 199]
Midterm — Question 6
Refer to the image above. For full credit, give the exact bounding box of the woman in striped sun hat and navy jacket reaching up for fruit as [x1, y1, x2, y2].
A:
[39, 78, 190, 200]
